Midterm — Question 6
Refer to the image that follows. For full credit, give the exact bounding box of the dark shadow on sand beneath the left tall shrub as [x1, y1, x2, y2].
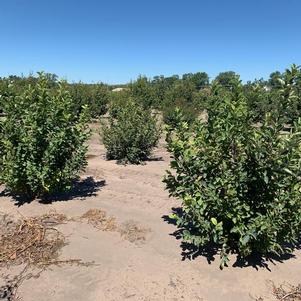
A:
[0, 177, 106, 206]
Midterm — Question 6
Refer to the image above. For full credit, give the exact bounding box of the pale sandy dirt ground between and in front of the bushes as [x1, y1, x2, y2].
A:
[0, 125, 301, 301]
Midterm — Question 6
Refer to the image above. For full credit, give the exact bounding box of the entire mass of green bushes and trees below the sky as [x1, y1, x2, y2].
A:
[0, 65, 301, 266]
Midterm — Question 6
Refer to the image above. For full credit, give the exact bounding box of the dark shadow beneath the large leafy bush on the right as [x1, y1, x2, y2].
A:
[162, 207, 301, 271]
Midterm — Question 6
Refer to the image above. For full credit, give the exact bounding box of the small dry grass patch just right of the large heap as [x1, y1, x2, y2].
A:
[81, 209, 117, 231]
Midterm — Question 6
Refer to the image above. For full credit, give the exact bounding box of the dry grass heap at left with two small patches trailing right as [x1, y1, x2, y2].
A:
[0, 209, 150, 266]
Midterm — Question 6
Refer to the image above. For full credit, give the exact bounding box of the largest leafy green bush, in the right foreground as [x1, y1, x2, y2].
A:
[164, 79, 301, 267]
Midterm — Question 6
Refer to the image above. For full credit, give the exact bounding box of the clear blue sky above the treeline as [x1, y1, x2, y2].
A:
[0, 0, 301, 83]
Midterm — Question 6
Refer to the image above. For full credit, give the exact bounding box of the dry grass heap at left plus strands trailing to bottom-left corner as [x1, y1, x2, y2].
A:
[0, 212, 94, 301]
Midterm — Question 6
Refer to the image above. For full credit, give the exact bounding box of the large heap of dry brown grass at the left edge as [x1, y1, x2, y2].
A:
[0, 213, 66, 265]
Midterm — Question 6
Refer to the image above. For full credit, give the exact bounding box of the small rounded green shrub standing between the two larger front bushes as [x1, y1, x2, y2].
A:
[102, 100, 160, 164]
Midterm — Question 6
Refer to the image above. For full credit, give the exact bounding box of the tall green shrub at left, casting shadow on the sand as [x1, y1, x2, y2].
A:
[0, 73, 89, 197]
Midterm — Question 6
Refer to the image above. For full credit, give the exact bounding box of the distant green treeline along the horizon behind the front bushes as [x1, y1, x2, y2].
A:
[0, 65, 301, 124]
